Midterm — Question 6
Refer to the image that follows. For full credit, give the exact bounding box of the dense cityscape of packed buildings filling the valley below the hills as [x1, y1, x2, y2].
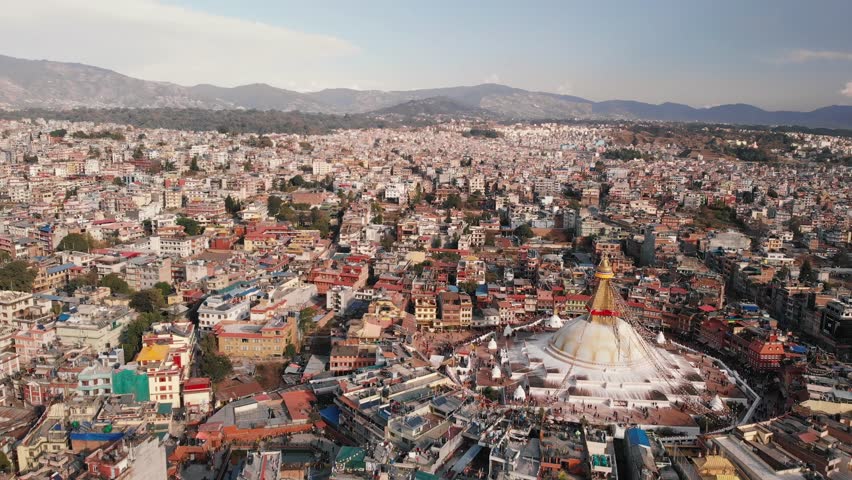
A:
[0, 114, 852, 480]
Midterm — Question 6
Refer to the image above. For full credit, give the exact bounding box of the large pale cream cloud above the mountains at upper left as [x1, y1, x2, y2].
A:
[0, 0, 358, 86]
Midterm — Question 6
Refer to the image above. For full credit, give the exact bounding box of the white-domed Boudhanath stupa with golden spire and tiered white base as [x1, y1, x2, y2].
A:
[490, 258, 748, 407]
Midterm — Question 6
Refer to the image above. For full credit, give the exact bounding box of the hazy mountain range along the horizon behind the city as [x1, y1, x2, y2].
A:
[5, 55, 852, 128]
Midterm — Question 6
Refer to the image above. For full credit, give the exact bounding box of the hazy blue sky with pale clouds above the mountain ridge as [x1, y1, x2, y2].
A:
[0, 0, 852, 110]
